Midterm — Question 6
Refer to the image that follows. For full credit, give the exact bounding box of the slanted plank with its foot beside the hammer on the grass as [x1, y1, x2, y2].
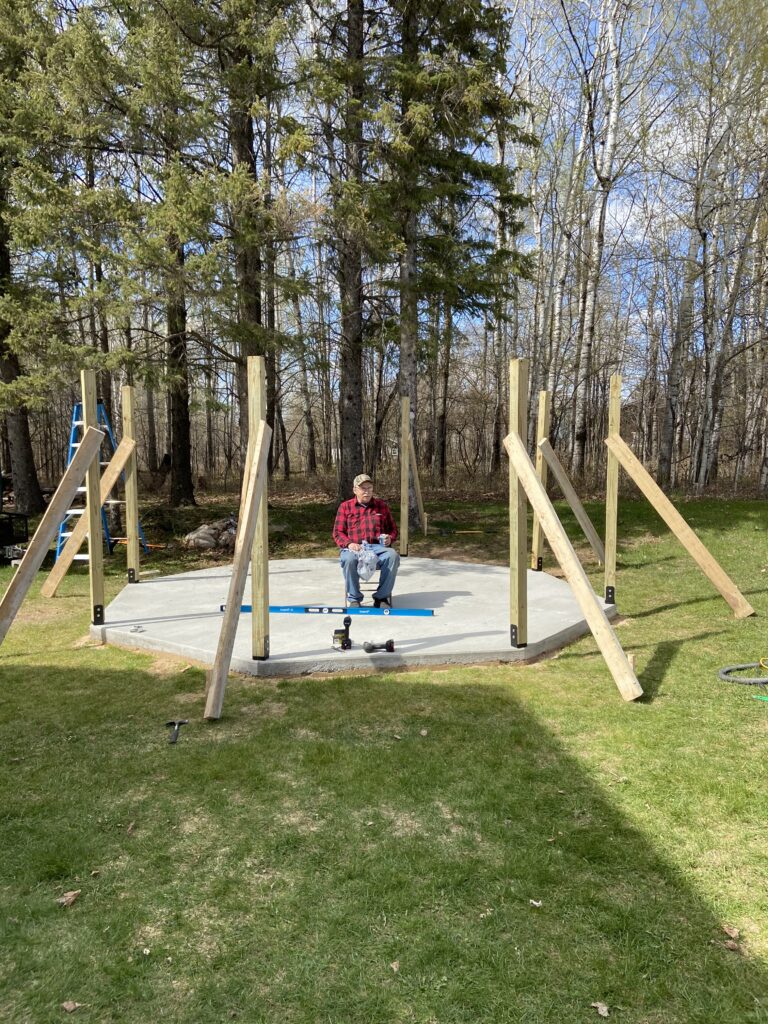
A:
[205, 420, 272, 719]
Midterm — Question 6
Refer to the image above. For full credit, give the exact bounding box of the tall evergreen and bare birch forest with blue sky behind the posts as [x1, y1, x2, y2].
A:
[0, 0, 768, 513]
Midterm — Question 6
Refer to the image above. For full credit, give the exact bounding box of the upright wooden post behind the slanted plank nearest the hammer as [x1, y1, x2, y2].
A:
[249, 355, 269, 662]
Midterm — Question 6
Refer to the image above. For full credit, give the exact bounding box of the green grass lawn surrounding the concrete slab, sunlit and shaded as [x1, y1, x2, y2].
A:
[0, 499, 768, 1024]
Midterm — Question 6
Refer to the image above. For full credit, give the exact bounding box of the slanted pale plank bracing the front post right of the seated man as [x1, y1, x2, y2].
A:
[504, 434, 643, 700]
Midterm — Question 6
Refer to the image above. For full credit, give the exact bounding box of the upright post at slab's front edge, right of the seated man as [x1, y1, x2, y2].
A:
[509, 359, 528, 647]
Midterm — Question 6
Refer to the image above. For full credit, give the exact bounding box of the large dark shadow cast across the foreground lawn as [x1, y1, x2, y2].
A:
[0, 659, 768, 1024]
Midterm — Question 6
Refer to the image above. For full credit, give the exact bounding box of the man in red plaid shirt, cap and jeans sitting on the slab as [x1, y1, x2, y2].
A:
[334, 473, 400, 608]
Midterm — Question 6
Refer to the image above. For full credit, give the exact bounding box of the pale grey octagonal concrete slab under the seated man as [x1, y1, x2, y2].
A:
[91, 557, 615, 676]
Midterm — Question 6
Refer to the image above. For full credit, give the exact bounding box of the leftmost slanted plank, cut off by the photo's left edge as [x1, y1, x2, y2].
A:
[0, 427, 104, 643]
